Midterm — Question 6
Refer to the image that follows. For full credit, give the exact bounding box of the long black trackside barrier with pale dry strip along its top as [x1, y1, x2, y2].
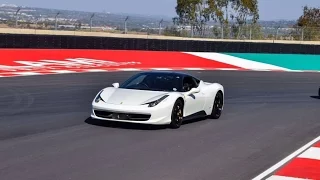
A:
[0, 26, 320, 54]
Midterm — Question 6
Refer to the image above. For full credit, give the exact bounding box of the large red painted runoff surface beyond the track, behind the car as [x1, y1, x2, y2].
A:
[0, 49, 239, 68]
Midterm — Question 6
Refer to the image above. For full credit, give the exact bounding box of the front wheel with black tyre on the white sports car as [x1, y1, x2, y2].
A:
[170, 99, 183, 129]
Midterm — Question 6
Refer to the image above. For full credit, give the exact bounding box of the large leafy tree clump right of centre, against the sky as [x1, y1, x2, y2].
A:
[173, 0, 259, 38]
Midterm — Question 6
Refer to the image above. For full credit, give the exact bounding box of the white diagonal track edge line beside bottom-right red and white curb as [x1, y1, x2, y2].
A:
[252, 136, 320, 180]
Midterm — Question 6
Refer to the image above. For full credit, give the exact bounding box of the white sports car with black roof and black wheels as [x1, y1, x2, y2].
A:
[91, 71, 224, 128]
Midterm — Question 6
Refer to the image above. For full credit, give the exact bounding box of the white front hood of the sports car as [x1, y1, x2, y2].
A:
[100, 88, 168, 105]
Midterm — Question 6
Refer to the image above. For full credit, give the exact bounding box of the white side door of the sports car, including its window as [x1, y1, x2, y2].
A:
[183, 76, 205, 116]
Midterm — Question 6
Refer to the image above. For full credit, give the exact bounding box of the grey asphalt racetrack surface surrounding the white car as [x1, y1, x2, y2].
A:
[0, 71, 320, 180]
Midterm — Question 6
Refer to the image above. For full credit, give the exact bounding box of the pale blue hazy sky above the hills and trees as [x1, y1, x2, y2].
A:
[0, 0, 320, 20]
